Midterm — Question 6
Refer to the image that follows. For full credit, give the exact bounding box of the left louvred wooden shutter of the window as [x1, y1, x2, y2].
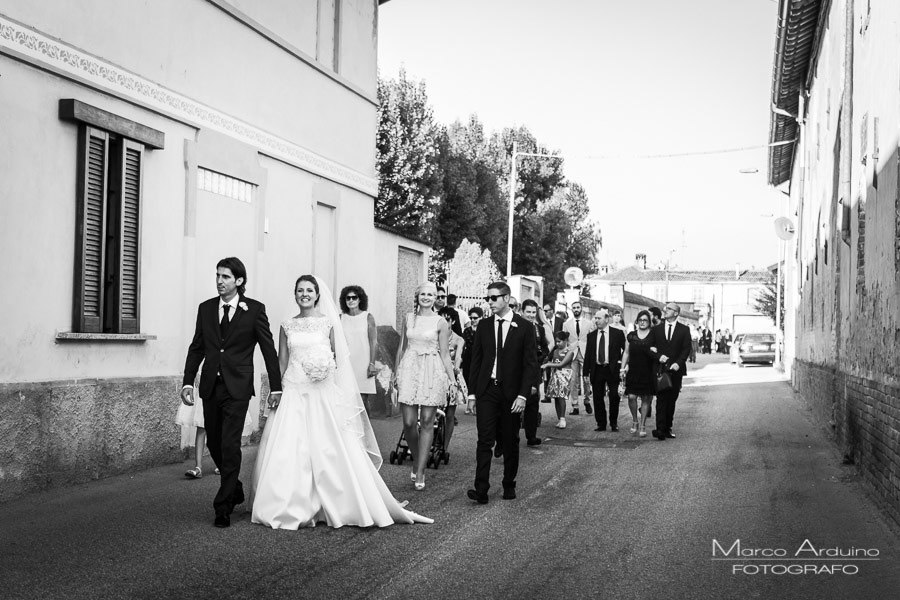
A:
[73, 126, 109, 333]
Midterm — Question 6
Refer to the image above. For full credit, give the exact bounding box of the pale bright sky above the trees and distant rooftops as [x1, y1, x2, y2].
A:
[378, 0, 787, 269]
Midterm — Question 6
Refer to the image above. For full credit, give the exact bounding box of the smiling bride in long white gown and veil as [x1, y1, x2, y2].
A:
[252, 275, 433, 529]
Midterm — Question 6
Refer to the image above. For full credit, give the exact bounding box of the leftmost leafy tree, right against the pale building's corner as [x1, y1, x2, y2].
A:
[375, 70, 441, 241]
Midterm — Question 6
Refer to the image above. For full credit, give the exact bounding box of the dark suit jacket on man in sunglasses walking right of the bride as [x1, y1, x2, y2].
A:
[469, 315, 541, 402]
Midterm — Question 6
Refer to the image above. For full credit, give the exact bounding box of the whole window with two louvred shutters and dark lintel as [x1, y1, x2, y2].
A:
[60, 100, 162, 334]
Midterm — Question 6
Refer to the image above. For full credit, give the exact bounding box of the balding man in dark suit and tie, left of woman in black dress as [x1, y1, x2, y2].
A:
[582, 308, 625, 431]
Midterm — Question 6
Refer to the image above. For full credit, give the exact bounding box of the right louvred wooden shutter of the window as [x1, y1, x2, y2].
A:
[111, 139, 144, 333]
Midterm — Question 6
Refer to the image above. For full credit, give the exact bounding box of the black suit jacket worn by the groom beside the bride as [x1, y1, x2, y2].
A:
[182, 296, 281, 400]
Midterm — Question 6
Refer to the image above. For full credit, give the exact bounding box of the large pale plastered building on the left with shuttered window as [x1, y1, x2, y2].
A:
[0, 0, 427, 500]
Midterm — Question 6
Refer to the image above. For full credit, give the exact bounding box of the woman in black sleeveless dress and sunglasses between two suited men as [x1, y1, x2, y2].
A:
[622, 310, 656, 437]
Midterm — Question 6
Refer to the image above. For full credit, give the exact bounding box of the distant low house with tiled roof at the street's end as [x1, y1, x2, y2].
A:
[584, 255, 774, 332]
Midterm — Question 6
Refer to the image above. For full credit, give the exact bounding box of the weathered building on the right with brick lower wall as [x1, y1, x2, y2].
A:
[769, 0, 900, 521]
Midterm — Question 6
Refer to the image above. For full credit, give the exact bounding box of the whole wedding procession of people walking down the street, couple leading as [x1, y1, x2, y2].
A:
[179, 257, 703, 529]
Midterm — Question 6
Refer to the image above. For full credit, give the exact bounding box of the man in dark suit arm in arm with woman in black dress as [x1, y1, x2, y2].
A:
[650, 302, 691, 441]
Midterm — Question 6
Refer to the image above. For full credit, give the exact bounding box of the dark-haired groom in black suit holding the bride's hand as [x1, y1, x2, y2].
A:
[181, 257, 281, 527]
